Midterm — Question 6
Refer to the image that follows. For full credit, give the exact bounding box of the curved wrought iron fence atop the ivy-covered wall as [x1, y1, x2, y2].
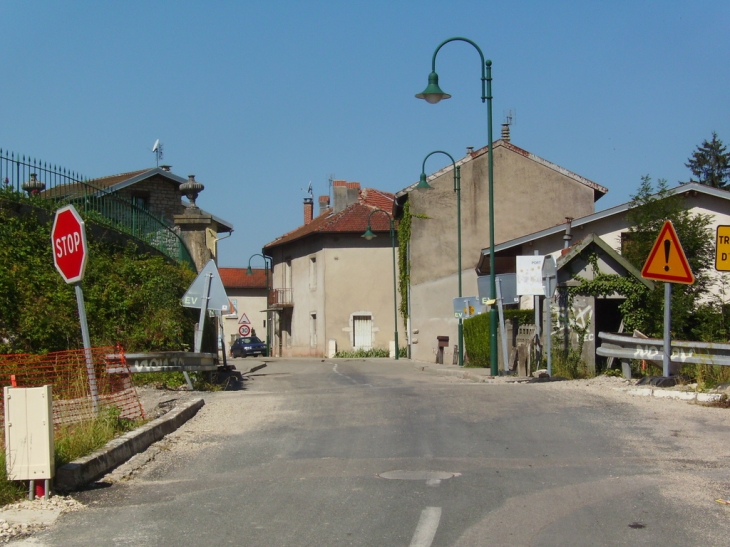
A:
[0, 149, 196, 271]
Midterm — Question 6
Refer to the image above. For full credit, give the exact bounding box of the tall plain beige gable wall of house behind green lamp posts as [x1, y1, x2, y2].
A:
[396, 133, 608, 362]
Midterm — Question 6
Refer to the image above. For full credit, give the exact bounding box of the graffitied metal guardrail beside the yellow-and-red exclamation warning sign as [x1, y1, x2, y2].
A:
[596, 332, 730, 366]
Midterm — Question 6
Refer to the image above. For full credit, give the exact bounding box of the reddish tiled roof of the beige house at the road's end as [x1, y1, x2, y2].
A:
[264, 188, 395, 249]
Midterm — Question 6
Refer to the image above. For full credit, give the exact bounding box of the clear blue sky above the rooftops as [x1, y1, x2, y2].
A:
[0, 0, 730, 267]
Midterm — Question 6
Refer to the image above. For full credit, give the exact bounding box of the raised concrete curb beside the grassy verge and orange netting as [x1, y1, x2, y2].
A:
[54, 399, 205, 492]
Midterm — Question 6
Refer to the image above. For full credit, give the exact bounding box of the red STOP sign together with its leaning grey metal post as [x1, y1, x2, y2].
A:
[51, 205, 99, 414]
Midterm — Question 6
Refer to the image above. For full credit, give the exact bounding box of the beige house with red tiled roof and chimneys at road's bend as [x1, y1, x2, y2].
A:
[263, 181, 397, 357]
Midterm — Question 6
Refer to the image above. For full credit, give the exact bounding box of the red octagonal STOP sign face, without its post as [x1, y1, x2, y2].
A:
[51, 205, 89, 283]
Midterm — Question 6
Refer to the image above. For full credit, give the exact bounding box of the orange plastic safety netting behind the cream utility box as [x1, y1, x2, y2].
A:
[0, 347, 144, 428]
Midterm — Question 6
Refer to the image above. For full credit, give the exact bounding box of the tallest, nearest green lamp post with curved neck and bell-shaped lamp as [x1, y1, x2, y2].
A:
[416, 37, 498, 376]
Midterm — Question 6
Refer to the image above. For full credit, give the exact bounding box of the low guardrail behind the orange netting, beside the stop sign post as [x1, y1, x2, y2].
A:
[106, 351, 218, 374]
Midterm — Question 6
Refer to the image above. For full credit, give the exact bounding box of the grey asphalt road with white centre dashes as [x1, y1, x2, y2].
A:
[17, 359, 730, 547]
